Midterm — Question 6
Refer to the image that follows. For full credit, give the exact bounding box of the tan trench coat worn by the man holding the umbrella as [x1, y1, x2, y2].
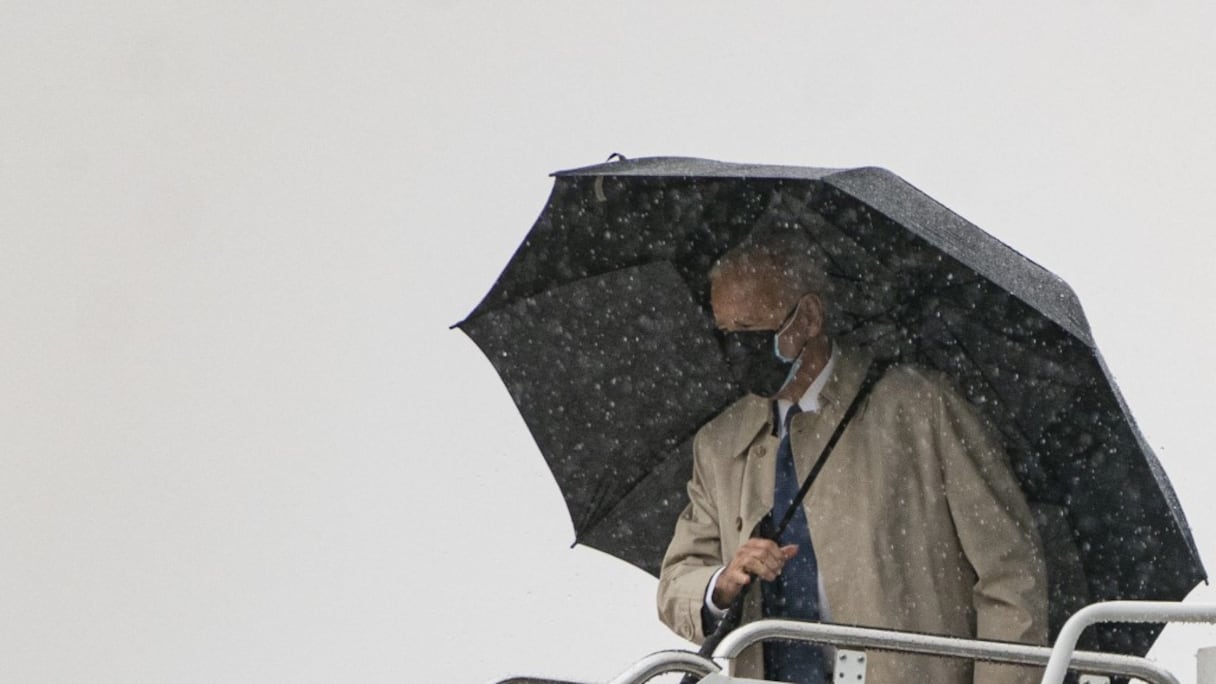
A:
[658, 351, 1047, 684]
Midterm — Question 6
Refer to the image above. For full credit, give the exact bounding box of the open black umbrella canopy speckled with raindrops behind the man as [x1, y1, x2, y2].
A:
[457, 158, 1205, 654]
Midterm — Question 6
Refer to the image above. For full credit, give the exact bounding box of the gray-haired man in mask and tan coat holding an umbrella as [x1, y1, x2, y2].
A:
[658, 229, 1047, 684]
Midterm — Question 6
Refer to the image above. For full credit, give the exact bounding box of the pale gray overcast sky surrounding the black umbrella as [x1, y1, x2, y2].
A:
[0, 0, 1216, 683]
